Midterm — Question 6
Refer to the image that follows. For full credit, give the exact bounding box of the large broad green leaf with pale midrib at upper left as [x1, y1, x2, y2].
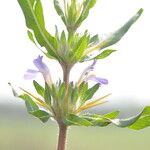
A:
[18, 0, 58, 58]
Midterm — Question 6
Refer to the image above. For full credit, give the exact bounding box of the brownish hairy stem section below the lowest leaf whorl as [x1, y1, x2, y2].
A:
[57, 124, 67, 150]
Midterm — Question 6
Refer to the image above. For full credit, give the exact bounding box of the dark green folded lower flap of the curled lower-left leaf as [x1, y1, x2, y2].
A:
[32, 110, 50, 123]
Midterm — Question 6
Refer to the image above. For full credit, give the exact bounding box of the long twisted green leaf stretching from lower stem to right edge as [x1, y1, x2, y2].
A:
[66, 106, 150, 130]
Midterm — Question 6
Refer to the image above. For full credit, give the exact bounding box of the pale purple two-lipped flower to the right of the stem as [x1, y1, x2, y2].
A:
[78, 60, 108, 85]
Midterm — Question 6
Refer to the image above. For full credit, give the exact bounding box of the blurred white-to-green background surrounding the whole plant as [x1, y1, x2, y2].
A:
[0, 0, 150, 150]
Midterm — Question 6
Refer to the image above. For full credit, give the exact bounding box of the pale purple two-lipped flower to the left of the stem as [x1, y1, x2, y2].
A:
[24, 55, 52, 86]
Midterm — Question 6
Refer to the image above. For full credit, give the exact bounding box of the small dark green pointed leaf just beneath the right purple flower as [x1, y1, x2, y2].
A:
[81, 84, 100, 103]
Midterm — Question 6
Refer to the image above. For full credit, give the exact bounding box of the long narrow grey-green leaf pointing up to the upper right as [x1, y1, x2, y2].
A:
[96, 9, 143, 49]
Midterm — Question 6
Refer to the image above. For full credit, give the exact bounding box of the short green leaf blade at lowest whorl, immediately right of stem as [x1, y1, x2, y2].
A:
[65, 114, 93, 126]
